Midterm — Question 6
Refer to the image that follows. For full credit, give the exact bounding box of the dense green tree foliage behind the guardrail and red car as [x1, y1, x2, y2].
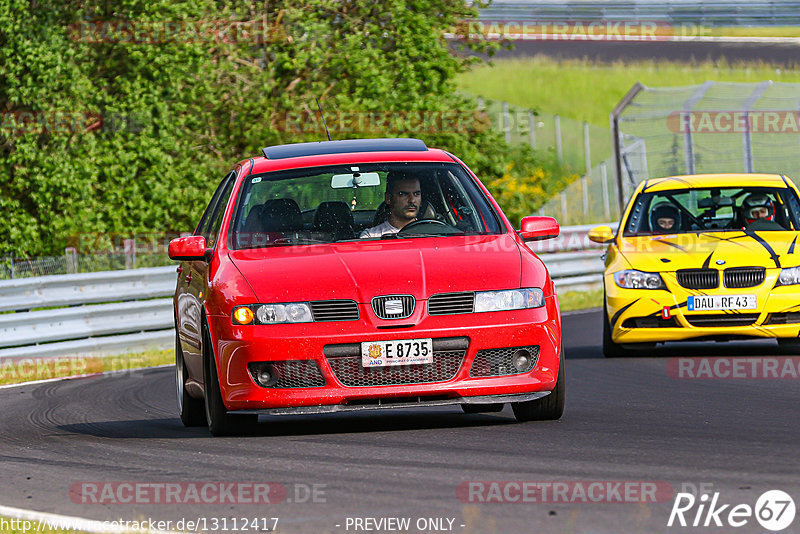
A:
[0, 0, 559, 255]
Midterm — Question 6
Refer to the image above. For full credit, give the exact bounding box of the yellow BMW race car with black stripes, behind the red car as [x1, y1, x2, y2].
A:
[589, 174, 800, 356]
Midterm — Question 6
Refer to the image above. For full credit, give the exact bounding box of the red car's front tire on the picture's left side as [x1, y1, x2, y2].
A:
[203, 327, 258, 436]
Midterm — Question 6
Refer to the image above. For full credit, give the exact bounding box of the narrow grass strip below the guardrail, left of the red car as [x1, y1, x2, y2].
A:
[0, 349, 170, 385]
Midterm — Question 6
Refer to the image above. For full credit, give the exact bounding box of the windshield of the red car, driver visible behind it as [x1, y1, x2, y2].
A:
[229, 163, 502, 249]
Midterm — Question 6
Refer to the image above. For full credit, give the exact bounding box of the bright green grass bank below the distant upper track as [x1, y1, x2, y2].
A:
[456, 56, 800, 128]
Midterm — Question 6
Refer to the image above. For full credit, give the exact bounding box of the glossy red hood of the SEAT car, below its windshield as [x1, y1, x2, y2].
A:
[228, 234, 520, 303]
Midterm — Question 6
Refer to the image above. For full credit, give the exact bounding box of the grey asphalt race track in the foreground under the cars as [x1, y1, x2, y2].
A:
[0, 311, 800, 534]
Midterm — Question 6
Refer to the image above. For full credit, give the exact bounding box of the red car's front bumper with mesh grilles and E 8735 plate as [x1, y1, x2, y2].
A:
[203, 297, 561, 413]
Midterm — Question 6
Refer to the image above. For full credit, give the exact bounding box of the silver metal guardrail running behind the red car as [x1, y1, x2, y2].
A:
[0, 226, 603, 361]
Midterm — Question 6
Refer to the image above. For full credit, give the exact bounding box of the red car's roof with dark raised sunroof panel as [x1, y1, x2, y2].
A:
[242, 139, 456, 174]
